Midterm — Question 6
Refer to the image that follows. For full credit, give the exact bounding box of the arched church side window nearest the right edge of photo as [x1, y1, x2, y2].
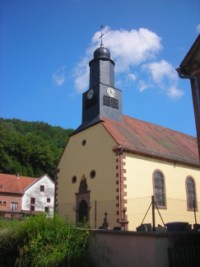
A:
[186, 177, 197, 211]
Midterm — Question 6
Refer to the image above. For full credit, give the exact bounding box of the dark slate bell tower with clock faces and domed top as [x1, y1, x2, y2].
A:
[78, 43, 122, 130]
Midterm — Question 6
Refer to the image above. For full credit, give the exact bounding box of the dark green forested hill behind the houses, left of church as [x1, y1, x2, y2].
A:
[0, 118, 73, 179]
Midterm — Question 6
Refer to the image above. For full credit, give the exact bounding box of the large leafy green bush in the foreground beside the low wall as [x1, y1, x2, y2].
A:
[0, 215, 95, 267]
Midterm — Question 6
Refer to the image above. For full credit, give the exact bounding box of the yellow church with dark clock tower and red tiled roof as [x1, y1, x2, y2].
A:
[56, 39, 200, 230]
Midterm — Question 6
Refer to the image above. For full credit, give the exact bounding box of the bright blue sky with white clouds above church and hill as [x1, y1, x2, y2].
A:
[0, 0, 200, 136]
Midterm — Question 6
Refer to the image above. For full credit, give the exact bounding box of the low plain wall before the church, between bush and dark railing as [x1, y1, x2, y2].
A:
[90, 230, 172, 267]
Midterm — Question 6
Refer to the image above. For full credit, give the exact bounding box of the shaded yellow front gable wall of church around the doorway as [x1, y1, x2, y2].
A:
[57, 124, 117, 228]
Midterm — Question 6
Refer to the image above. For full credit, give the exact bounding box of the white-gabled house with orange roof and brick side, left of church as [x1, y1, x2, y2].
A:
[0, 174, 55, 218]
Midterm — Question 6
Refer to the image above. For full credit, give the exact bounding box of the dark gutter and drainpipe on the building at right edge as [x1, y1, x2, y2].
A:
[176, 68, 200, 162]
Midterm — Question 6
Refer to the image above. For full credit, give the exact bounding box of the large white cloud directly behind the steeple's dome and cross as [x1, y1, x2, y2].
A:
[74, 27, 162, 92]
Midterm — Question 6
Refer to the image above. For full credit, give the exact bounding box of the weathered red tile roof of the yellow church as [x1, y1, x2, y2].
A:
[101, 116, 200, 167]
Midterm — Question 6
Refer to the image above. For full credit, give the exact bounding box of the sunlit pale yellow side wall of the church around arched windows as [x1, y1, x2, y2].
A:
[124, 153, 200, 230]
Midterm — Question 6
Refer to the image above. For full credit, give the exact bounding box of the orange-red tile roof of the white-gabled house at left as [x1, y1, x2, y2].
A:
[0, 173, 38, 194]
